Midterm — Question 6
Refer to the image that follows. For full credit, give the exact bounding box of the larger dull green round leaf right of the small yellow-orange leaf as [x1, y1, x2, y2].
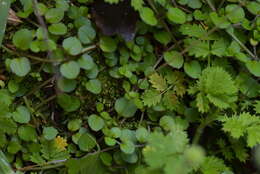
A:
[78, 133, 96, 152]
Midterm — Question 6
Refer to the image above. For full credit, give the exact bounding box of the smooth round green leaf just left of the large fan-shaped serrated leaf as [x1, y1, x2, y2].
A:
[184, 60, 201, 79]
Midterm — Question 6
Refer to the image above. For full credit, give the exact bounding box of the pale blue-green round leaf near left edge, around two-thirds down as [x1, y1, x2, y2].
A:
[12, 106, 31, 123]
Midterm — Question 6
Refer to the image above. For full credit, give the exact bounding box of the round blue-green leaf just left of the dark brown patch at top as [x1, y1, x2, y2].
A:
[78, 25, 96, 44]
